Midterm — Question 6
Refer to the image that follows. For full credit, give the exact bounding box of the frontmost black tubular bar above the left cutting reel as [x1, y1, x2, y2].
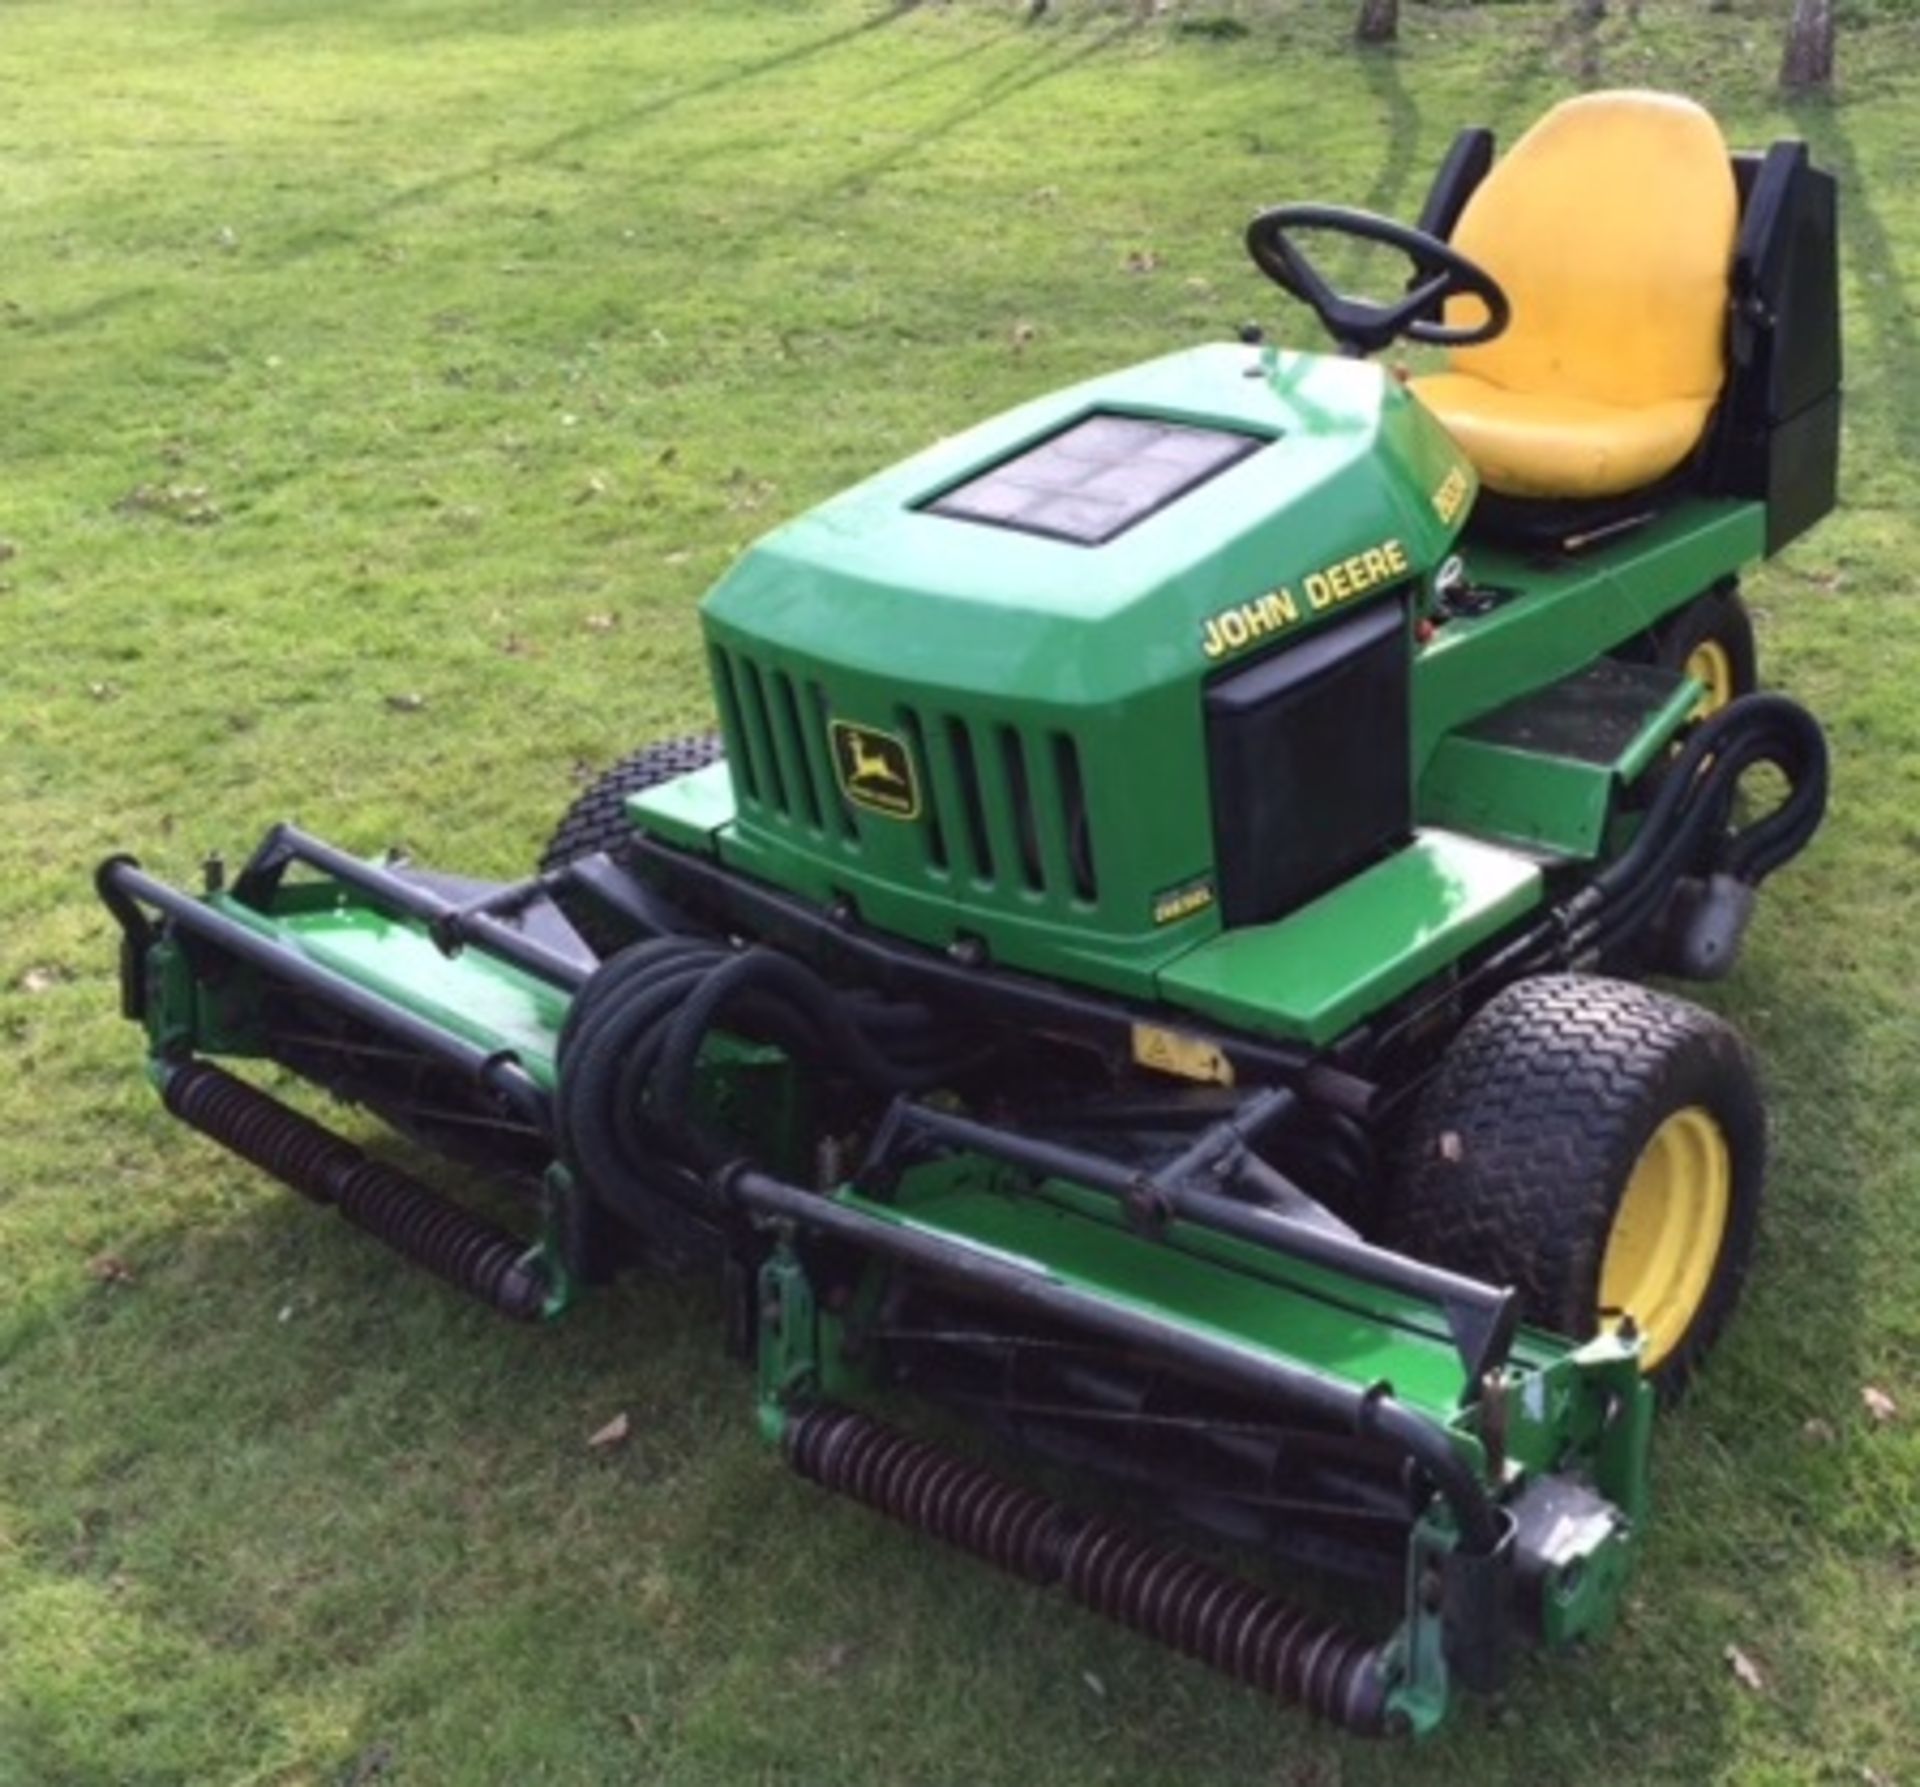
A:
[94, 856, 553, 1138]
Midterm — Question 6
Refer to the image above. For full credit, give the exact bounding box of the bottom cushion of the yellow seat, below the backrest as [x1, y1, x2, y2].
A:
[1413, 372, 1713, 499]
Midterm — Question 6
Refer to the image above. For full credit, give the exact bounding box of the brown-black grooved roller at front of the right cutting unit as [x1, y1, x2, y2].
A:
[783, 1405, 1394, 1737]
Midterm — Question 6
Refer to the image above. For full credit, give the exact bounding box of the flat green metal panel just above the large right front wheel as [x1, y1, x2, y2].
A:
[1158, 831, 1540, 1042]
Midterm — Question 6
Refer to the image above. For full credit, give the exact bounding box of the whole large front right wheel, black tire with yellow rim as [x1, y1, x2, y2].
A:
[1384, 975, 1766, 1399]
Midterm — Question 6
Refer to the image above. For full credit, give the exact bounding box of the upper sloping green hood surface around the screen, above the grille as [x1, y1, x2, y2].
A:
[703, 345, 1473, 708]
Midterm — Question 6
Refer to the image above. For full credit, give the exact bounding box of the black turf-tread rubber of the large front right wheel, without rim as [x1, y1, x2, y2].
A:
[1382, 975, 1766, 1399]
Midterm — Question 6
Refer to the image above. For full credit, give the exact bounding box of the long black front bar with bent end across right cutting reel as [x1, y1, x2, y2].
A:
[714, 1163, 1505, 1557]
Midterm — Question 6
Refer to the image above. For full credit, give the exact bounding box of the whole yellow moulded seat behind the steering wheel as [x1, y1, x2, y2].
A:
[1413, 92, 1740, 499]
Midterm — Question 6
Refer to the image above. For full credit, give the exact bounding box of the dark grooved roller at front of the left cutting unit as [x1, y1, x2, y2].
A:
[161, 1061, 545, 1321]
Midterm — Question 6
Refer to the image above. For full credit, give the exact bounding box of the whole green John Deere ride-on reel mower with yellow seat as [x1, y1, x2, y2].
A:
[100, 94, 1839, 1733]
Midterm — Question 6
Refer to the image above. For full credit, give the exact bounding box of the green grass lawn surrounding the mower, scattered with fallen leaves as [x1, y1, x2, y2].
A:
[0, 0, 1920, 1787]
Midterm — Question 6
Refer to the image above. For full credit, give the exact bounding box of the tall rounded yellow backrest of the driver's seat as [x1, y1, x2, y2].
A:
[1450, 92, 1740, 405]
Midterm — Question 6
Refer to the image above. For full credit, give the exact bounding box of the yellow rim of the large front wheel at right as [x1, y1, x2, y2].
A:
[1599, 1104, 1734, 1370]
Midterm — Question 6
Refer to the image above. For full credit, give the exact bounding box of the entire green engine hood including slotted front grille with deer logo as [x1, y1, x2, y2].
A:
[668, 345, 1475, 990]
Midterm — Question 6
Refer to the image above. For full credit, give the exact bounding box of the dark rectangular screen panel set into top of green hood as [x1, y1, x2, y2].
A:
[924, 415, 1265, 545]
